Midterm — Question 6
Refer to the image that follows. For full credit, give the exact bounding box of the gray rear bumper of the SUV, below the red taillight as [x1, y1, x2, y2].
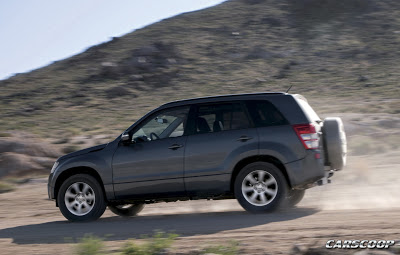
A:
[285, 150, 325, 189]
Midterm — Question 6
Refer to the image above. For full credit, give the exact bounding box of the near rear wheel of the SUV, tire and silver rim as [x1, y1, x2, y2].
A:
[234, 162, 288, 213]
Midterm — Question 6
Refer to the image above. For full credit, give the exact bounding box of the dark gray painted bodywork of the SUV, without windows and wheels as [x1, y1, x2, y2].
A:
[49, 93, 324, 203]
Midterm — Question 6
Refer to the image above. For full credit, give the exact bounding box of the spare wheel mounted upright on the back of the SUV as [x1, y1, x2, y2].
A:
[322, 117, 347, 170]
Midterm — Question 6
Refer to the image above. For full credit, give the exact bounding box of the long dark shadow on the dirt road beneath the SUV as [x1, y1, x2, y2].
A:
[0, 208, 318, 244]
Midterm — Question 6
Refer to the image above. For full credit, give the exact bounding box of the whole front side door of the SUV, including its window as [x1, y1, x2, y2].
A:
[113, 106, 190, 199]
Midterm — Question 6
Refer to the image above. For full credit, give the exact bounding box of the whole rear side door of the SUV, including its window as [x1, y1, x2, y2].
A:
[184, 101, 258, 196]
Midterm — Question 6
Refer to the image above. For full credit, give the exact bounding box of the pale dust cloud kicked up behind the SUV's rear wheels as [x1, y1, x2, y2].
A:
[300, 151, 400, 210]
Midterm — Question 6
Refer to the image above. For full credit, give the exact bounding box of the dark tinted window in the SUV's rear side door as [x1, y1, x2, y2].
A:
[195, 103, 250, 134]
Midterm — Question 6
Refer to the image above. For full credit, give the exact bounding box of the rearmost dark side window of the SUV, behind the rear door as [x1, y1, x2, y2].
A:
[246, 100, 288, 127]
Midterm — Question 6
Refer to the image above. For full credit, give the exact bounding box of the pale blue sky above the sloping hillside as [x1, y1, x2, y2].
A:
[0, 0, 223, 80]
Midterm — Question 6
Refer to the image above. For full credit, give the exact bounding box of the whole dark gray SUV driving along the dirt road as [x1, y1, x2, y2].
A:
[48, 93, 347, 221]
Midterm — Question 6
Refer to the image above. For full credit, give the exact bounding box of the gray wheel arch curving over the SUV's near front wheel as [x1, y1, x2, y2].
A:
[54, 166, 107, 206]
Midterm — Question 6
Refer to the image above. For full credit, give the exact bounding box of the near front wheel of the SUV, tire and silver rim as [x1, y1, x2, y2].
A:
[57, 174, 107, 222]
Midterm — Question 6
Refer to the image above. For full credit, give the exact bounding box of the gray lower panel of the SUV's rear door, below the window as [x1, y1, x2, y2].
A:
[185, 128, 258, 196]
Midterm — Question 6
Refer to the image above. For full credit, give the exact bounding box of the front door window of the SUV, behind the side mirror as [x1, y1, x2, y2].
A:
[132, 106, 190, 142]
